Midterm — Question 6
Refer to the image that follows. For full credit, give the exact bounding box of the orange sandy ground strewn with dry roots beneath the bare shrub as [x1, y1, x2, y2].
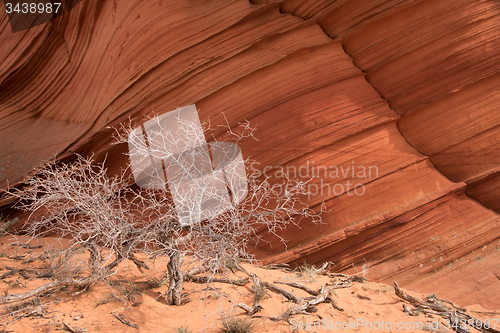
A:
[0, 236, 500, 333]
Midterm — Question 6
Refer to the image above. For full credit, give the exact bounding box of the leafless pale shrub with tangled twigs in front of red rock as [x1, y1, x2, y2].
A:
[9, 106, 324, 307]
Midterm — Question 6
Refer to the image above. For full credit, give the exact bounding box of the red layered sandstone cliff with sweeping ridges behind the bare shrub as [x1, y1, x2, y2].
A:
[0, 0, 500, 308]
